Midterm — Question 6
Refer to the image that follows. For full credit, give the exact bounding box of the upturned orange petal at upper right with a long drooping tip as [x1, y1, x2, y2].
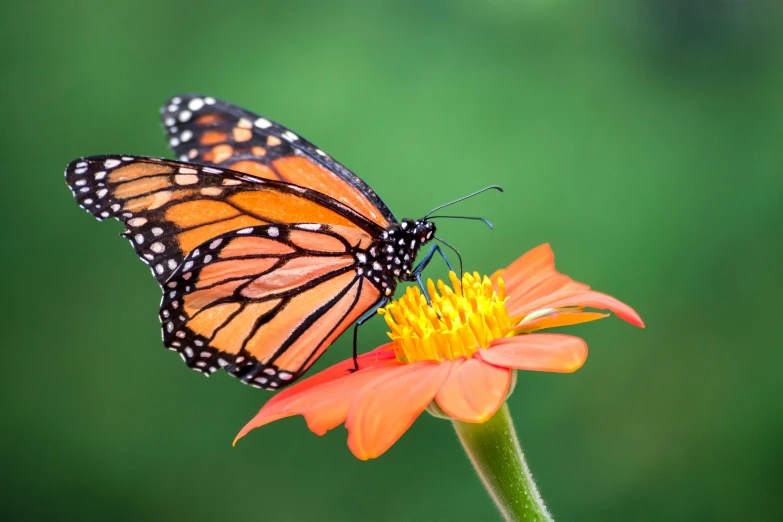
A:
[500, 244, 644, 327]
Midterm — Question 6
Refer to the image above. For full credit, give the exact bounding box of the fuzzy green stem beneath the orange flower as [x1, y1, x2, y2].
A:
[454, 404, 552, 522]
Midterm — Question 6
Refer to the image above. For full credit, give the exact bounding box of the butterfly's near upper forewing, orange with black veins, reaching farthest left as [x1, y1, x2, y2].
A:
[65, 156, 382, 284]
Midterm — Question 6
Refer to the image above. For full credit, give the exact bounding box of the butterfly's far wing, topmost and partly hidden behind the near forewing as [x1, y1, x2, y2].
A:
[161, 95, 397, 228]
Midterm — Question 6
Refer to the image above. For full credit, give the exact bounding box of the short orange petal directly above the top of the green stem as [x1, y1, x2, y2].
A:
[435, 357, 511, 422]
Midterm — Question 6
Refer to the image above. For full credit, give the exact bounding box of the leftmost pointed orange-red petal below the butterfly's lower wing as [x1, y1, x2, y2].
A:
[234, 350, 402, 444]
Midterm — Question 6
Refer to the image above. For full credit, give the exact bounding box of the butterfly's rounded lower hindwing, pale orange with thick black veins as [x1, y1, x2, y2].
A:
[160, 223, 382, 389]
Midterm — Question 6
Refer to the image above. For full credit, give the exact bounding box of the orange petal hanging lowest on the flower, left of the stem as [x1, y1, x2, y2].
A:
[345, 361, 451, 460]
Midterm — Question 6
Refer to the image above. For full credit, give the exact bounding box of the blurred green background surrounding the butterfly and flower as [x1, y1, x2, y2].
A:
[0, 0, 783, 521]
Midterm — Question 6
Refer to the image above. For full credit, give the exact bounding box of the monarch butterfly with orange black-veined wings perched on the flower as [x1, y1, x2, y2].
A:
[65, 95, 499, 389]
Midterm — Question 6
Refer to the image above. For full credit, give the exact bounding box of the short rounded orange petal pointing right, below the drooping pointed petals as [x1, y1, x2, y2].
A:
[478, 334, 587, 373]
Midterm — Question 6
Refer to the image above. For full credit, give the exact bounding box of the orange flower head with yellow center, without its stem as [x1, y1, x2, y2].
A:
[234, 244, 644, 460]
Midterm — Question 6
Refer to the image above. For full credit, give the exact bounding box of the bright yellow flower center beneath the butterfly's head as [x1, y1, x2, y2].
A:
[378, 272, 512, 363]
